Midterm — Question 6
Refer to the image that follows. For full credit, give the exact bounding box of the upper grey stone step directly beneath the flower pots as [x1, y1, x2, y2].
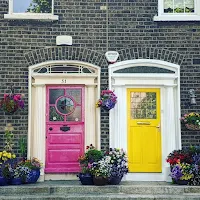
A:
[0, 181, 200, 196]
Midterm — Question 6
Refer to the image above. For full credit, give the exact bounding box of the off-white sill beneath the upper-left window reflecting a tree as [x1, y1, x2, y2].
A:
[4, 13, 59, 21]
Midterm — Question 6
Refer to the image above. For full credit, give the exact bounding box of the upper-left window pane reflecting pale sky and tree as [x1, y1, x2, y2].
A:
[13, 0, 52, 13]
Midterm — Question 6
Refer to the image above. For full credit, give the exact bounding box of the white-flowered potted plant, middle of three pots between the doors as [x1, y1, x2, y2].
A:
[91, 156, 111, 185]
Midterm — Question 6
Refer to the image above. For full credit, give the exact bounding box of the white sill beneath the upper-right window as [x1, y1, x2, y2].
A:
[153, 15, 200, 21]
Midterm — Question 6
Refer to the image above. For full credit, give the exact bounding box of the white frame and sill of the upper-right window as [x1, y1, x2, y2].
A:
[153, 0, 200, 21]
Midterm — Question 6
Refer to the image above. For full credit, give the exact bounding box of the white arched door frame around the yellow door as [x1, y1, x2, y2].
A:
[109, 59, 181, 181]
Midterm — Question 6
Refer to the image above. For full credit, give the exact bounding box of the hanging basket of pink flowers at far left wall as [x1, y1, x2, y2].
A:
[0, 93, 24, 114]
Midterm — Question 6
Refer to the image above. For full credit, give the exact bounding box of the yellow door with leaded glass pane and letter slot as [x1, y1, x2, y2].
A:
[127, 88, 161, 172]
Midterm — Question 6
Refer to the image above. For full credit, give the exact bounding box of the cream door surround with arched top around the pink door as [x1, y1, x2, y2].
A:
[27, 60, 100, 181]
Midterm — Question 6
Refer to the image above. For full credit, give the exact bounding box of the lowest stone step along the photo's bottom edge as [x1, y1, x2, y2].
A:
[0, 193, 200, 200]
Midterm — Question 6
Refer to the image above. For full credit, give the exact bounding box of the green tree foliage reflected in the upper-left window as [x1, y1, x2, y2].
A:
[27, 0, 52, 13]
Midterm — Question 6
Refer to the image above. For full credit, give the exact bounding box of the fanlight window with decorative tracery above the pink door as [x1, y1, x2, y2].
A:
[33, 64, 97, 74]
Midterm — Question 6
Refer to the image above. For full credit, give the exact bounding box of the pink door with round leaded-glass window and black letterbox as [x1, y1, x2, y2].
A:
[45, 86, 84, 173]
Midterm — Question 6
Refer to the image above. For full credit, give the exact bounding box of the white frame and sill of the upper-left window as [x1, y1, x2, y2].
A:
[4, 0, 58, 20]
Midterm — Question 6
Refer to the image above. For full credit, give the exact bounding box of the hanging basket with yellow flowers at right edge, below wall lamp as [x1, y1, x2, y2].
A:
[181, 112, 200, 130]
